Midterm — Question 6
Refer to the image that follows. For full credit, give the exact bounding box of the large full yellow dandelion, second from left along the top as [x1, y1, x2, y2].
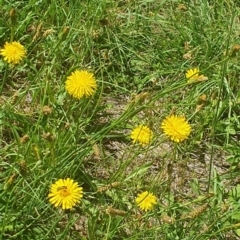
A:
[65, 70, 97, 99]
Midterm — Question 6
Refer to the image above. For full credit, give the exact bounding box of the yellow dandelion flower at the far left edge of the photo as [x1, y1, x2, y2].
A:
[0, 42, 26, 64]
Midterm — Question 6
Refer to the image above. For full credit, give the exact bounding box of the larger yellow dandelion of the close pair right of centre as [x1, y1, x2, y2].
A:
[161, 115, 191, 142]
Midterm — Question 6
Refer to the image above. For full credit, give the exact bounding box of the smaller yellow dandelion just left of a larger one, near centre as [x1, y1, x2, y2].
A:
[130, 125, 153, 146]
